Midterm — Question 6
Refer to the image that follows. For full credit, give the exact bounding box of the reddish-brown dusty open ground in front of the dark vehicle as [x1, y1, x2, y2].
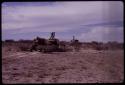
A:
[2, 50, 124, 83]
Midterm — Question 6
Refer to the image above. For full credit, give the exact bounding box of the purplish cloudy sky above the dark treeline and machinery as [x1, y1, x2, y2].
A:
[2, 1, 124, 42]
